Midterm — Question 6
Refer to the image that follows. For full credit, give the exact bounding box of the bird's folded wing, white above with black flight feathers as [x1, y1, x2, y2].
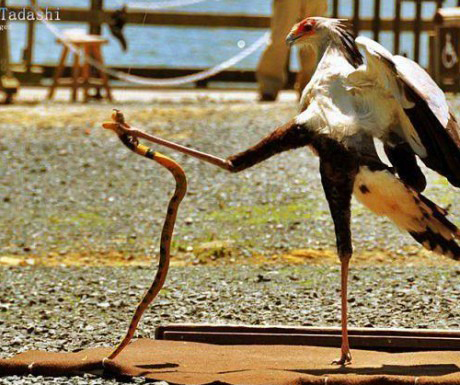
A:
[356, 37, 460, 187]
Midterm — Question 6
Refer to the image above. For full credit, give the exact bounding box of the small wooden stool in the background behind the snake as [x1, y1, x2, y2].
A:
[48, 34, 112, 102]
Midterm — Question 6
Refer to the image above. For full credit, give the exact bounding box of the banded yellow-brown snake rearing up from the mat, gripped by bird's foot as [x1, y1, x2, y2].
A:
[103, 110, 187, 360]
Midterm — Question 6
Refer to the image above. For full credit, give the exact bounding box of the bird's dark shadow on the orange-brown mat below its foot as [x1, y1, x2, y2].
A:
[286, 364, 460, 377]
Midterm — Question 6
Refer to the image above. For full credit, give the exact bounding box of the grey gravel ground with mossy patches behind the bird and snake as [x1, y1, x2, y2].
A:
[0, 98, 460, 384]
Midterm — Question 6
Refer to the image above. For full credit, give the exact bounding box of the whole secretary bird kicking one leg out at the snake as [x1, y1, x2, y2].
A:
[111, 17, 460, 365]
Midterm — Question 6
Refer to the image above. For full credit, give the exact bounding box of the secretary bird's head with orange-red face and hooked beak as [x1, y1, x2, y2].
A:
[286, 17, 348, 47]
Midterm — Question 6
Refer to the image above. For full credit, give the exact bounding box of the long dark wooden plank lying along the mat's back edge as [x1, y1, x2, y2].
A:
[155, 325, 460, 352]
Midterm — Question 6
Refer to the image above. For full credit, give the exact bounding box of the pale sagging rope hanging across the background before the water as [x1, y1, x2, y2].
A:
[32, 6, 270, 87]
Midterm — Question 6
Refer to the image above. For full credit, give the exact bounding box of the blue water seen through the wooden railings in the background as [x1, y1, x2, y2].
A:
[7, 0, 456, 69]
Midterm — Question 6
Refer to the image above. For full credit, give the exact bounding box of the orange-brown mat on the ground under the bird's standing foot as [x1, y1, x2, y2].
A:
[0, 339, 460, 385]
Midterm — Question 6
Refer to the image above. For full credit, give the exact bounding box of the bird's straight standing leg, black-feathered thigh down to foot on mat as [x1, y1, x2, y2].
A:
[320, 149, 356, 365]
